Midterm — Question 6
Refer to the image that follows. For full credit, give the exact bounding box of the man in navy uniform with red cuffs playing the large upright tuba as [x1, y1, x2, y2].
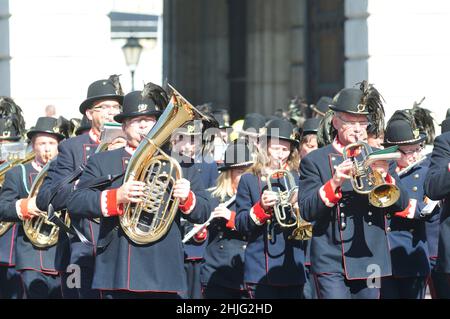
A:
[68, 85, 209, 298]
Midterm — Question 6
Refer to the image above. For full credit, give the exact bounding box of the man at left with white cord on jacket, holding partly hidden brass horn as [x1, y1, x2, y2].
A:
[0, 117, 65, 299]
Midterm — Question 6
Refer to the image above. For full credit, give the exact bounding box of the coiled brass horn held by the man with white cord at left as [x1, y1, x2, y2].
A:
[23, 162, 70, 248]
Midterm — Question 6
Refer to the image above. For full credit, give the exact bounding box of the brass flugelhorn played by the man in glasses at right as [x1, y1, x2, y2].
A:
[343, 141, 401, 208]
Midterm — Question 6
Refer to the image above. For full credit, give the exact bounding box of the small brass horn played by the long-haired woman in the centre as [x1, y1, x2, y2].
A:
[267, 169, 312, 240]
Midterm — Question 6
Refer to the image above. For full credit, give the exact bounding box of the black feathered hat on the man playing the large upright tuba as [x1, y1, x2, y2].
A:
[114, 82, 169, 123]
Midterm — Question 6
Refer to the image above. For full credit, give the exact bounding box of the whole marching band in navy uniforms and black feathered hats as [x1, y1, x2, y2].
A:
[0, 75, 450, 299]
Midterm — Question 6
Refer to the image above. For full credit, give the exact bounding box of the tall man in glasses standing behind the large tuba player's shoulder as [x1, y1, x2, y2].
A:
[36, 75, 123, 299]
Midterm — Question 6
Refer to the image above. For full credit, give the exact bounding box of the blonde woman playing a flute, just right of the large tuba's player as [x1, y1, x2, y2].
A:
[201, 141, 253, 299]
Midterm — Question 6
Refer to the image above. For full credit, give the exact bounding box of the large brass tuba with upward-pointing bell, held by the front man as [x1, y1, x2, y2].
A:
[119, 87, 211, 245]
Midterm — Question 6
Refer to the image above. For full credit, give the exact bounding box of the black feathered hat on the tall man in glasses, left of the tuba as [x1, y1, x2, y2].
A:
[80, 74, 123, 114]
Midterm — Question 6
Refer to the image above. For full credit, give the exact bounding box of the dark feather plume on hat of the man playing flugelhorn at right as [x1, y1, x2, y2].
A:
[359, 81, 385, 137]
